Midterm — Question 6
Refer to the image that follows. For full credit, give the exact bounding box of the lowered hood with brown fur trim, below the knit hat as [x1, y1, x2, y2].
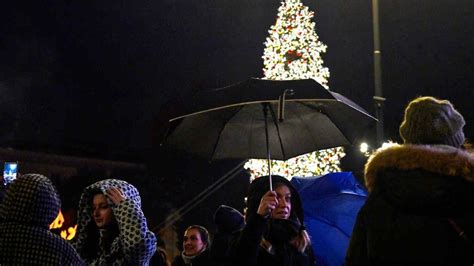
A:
[365, 144, 474, 213]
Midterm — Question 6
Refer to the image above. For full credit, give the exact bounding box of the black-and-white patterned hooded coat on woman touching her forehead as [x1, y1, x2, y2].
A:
[73, 179, 156, 265]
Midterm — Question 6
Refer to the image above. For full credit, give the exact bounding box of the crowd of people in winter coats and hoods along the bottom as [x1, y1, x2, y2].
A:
[0, 97, 474, 266]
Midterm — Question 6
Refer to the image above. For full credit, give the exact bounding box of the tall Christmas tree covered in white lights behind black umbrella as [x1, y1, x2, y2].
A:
[244, 0, 345, 178]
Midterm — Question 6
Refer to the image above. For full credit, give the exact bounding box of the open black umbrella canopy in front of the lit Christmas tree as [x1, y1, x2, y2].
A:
[163, 79, 376, 160]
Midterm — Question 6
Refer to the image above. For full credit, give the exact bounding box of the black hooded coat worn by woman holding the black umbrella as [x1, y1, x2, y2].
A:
[232, 176, 315, 266]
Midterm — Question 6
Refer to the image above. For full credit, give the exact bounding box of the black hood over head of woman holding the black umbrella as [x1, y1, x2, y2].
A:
[245, 175, 304, 224]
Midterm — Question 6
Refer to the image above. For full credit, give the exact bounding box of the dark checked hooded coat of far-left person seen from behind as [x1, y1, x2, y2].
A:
[0, 174, 84, 265]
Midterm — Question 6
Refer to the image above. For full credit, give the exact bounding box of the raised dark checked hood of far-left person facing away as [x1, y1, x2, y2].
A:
[0, 174, 61, 228]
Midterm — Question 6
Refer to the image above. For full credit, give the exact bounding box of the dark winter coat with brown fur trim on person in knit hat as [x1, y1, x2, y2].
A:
[346, 145, 474, 265]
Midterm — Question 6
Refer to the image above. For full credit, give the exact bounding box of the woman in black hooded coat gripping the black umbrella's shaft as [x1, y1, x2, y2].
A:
[232, 176, 315, 266]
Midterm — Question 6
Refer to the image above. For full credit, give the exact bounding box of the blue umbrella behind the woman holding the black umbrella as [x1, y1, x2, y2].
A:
[291, 172, 367, 266]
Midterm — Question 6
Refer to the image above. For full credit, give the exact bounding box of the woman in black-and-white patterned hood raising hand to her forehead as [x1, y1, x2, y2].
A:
[73, 179, 156, 265]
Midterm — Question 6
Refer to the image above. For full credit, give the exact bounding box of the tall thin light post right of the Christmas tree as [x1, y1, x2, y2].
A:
[372, 0, 385, 145]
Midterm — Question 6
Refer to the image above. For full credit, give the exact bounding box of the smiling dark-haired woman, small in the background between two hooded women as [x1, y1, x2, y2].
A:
[172, 225, 212, 266]
